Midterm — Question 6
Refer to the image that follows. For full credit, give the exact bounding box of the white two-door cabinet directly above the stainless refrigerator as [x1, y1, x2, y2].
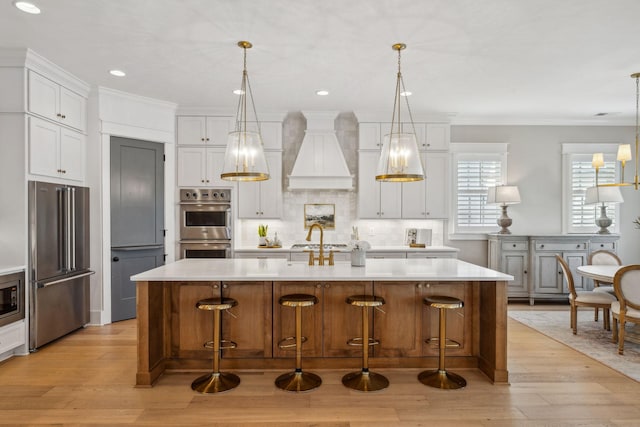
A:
[29, 117, 86, 181]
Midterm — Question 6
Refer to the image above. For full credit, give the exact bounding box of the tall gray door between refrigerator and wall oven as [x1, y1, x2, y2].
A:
[111, 137, 164, 322]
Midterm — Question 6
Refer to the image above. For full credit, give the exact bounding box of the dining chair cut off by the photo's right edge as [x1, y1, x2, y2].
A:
[611, 264, 640, 354]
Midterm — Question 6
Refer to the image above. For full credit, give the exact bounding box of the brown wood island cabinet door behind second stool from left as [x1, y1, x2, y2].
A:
[273, 282, 323, 358]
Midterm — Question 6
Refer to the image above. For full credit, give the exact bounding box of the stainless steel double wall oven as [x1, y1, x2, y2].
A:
[180, 188, 232, 258]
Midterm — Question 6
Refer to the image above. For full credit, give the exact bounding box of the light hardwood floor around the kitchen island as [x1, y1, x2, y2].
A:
[0, 306, 640, 427]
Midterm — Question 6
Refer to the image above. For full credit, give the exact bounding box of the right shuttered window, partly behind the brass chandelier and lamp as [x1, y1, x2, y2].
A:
[562, 144, 618, 233]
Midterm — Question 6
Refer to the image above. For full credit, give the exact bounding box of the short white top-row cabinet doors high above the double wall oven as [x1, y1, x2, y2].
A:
[177, 116, 235, 146]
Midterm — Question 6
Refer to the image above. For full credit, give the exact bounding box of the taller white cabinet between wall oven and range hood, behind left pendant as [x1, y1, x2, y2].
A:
[238, 151, 282, 219]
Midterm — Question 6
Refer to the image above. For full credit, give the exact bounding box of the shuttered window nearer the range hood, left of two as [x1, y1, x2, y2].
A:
[451, 143, 507, 234]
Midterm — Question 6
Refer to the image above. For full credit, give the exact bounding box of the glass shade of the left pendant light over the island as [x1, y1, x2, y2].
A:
[220, 130, 269, 181]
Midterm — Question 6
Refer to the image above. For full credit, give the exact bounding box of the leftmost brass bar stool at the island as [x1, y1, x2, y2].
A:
[191, 298, 240, 393]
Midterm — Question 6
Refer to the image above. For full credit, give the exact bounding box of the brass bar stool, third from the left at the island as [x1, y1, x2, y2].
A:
[342, 295, 389, 391]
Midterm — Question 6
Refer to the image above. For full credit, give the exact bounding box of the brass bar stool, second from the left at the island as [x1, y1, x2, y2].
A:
[276, 294, 322, 392]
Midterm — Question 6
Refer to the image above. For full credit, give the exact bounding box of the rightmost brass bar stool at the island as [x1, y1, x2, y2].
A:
[418, 295, 467, 389]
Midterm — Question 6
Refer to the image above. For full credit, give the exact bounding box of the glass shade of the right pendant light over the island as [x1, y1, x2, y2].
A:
[376, 133, 424, 182]
